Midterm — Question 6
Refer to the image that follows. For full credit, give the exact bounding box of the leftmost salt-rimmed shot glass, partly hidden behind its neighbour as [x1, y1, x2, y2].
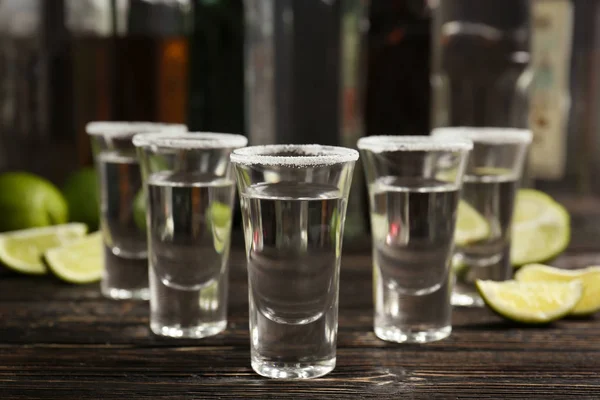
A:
[86, 122, 187, 300]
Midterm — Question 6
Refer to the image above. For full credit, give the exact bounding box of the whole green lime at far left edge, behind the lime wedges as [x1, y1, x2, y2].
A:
[0, 172, 69, 232]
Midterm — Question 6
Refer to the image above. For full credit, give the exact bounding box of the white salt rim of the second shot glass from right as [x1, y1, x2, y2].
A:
[358, 135, 473, 153]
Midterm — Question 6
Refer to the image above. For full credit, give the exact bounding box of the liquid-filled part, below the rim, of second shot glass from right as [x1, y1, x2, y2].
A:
[369, 177, 460, 342]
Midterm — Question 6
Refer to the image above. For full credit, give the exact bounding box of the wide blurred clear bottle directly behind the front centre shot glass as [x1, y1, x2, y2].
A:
[244, 0, 368, 238]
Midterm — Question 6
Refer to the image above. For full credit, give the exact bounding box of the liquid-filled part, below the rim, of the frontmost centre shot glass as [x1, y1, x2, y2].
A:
[241, 182, 346, 378]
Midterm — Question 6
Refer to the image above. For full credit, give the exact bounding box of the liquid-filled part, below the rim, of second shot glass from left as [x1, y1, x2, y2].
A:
[148, 172, 235, 338]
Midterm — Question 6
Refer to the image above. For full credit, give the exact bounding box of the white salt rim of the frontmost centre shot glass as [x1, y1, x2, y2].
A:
[231, 144, 358, 167]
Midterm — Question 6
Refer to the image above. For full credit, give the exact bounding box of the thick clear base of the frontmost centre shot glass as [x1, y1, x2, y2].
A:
[252, 357, 336, 379]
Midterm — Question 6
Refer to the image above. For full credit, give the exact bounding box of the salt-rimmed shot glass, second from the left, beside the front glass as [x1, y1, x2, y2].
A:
[133, 132, 247, 338]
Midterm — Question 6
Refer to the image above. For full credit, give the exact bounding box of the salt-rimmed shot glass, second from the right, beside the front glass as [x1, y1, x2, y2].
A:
[358, 136, 473, 343]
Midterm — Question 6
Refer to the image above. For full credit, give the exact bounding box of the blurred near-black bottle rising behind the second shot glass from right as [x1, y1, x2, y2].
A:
[365, 0, 431, 135]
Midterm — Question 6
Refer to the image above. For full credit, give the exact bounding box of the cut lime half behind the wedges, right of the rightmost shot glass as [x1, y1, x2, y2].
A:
[510, 189, 571, 266]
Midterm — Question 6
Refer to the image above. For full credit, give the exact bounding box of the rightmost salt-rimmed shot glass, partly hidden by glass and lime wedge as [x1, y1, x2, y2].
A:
[432, 127, 532, 307]
